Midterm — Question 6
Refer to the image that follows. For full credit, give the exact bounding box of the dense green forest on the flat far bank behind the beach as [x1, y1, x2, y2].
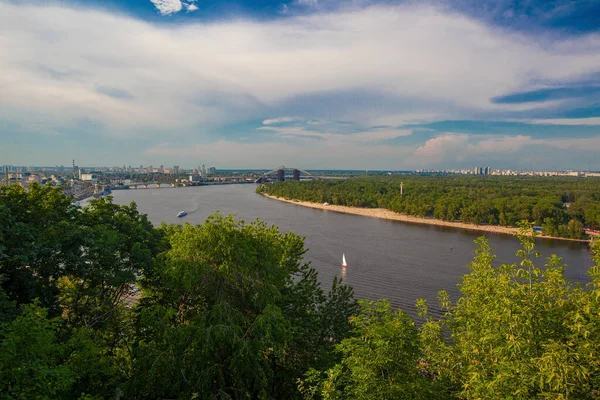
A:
[257, 175, 600, 239]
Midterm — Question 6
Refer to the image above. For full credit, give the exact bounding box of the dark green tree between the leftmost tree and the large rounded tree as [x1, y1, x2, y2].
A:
[60, 197, 165, 329]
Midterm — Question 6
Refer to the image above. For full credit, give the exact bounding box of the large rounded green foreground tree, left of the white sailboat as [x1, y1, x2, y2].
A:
[127, 214, 356, 398]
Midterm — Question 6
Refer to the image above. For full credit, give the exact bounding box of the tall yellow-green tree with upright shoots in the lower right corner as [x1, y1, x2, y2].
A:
[418, 228, 600, 399]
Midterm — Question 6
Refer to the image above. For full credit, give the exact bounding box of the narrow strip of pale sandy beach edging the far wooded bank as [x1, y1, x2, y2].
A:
[262, 193, 590, 243]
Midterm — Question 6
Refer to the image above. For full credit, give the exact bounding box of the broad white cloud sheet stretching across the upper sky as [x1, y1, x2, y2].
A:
[0, 0, 600, 165]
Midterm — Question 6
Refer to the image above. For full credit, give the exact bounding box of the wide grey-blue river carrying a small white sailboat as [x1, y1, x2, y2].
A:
[113, 184, 593, 316]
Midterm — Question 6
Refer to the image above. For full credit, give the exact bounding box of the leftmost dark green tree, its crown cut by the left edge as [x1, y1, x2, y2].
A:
[0, 184, 86, 315]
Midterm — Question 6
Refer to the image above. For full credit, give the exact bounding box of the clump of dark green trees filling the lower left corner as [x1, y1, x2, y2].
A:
[0, 185, 163, 398]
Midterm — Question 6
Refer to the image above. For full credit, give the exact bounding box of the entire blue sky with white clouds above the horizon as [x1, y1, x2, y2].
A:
[0, 0, 600, 170]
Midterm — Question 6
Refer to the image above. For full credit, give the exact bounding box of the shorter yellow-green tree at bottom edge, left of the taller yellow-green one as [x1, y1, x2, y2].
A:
[300, 300, 449, 400]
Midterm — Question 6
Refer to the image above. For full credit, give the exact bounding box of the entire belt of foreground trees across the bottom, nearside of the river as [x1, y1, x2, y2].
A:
[0, 185, 600, 400]
